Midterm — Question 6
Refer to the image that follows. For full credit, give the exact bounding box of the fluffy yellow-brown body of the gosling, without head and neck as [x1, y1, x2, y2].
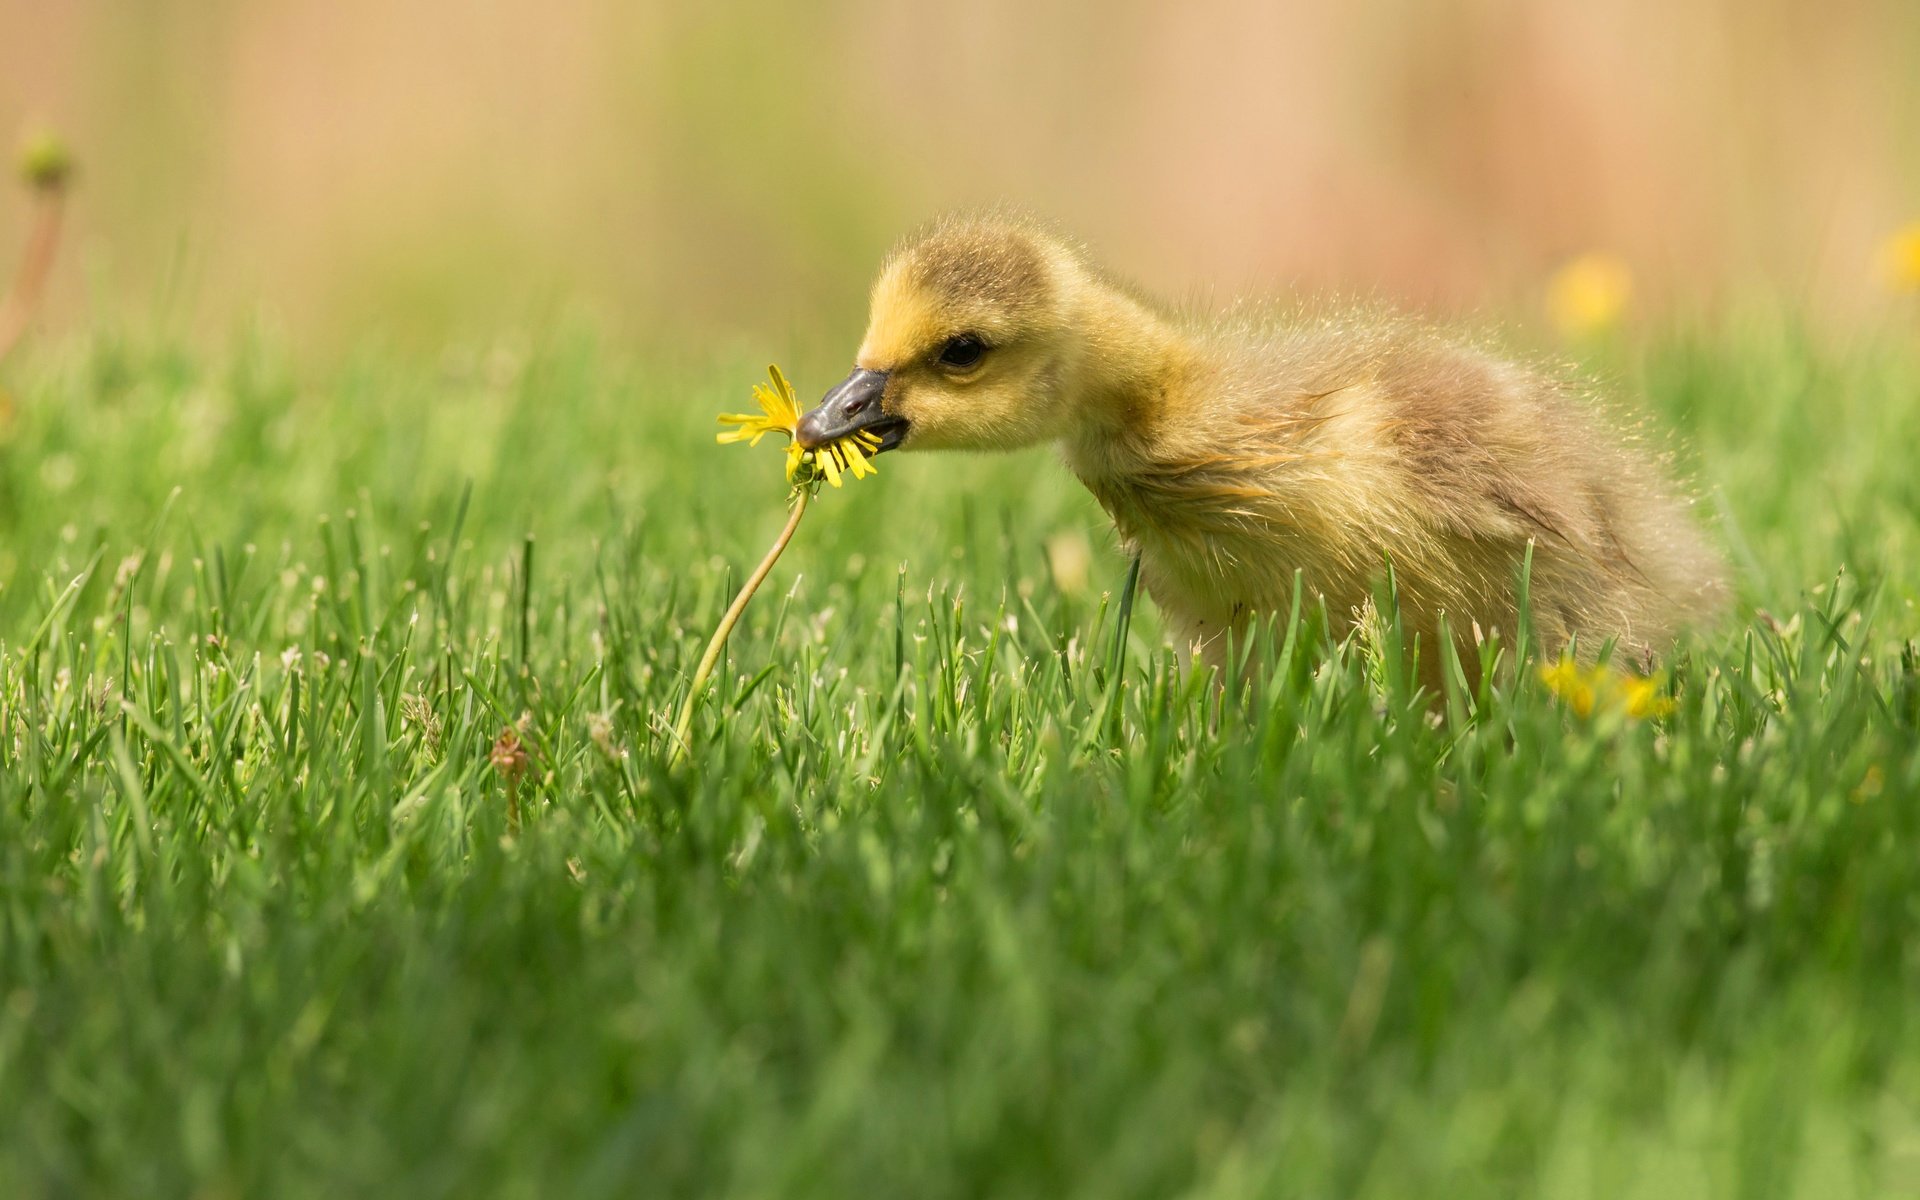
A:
[1068, 315, 1724, 666]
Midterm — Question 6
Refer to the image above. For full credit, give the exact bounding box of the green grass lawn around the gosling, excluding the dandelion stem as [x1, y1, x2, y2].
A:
[0, 321, 1920, 1198]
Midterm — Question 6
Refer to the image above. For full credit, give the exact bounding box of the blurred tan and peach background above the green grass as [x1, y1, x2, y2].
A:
[0, 0, 1920, 349]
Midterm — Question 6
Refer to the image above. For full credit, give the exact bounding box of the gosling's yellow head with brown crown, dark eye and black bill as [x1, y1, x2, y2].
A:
[799, 219, 1144, 449]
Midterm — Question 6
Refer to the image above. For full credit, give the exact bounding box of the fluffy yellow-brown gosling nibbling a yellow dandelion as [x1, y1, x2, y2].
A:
[799, 217, 1724, 682]
